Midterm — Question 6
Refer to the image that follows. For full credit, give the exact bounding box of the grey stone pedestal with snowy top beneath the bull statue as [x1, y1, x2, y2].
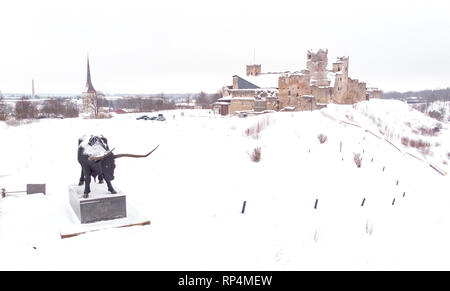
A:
[69, 182, 127, 224]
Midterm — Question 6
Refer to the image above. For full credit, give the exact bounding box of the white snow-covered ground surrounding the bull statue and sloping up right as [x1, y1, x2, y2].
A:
[0, 100, 450, 270]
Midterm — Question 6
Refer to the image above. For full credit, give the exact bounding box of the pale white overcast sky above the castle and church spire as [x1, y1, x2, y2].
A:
[0, 0, 450, 94]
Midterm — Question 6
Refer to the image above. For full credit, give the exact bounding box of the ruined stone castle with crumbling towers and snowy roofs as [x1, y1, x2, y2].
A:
[215, 49, 381, 115]
